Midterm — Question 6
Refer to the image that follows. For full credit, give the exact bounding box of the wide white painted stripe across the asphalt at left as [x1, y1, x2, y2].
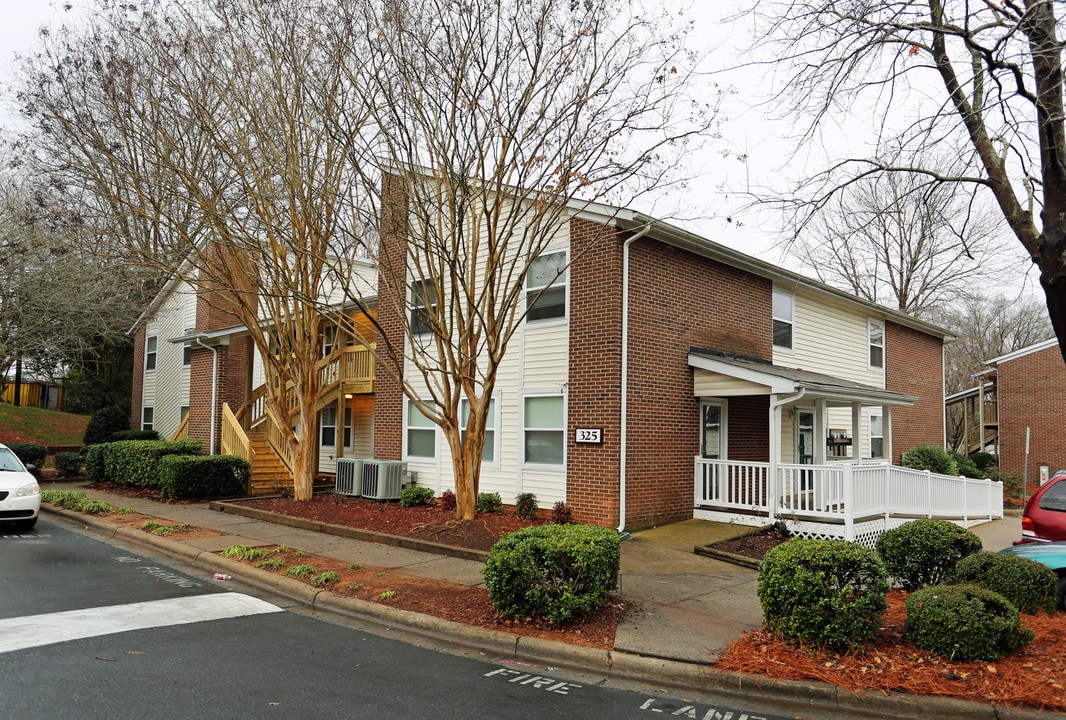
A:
[0, 592, 282, 653]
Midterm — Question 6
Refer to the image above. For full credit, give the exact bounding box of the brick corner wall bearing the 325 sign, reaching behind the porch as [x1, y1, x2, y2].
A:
[567, 231, 772, 528]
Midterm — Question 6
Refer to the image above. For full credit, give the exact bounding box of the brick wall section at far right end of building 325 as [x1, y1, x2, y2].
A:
[885, 322, 944, 462]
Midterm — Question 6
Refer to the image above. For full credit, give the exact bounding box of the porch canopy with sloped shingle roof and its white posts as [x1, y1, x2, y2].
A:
[689, 348, 918, 464]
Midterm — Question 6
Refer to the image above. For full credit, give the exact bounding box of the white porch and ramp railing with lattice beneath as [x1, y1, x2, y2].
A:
[694, 458, 1003, 545]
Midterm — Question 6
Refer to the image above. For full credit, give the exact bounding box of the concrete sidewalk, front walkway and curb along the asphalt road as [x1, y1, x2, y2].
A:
[42, 483, 1038, 719]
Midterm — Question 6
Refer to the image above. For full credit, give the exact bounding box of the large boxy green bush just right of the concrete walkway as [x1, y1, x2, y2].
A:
[757, 538, 888, 647]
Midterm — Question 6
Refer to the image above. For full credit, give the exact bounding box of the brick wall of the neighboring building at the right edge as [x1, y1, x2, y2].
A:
[998, 346, 1066, 483]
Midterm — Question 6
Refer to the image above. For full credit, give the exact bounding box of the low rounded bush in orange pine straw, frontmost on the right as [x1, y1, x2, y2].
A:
[904, 585, 1033, 660]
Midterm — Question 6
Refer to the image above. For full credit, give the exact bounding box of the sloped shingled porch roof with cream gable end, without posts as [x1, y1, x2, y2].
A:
[689, 348, 918, 405]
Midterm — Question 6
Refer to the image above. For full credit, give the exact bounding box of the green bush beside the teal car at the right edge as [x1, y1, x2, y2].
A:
[955, 550, 1059, 614]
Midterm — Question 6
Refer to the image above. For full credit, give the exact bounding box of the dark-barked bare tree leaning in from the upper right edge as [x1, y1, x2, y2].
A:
[750, 0, 1066, 357]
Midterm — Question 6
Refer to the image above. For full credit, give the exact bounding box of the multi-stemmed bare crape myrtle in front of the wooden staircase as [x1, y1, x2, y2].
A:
[11, 0, 370, 499]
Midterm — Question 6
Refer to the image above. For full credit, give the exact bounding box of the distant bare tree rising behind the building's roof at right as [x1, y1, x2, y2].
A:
[789, 174, 1007, 317]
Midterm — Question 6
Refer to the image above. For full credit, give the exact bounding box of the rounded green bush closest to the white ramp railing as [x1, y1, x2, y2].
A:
[876, 519, 982, 590]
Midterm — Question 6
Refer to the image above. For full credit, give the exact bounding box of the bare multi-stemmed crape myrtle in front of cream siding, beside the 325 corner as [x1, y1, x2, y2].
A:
[337, 0, 717, 519]
